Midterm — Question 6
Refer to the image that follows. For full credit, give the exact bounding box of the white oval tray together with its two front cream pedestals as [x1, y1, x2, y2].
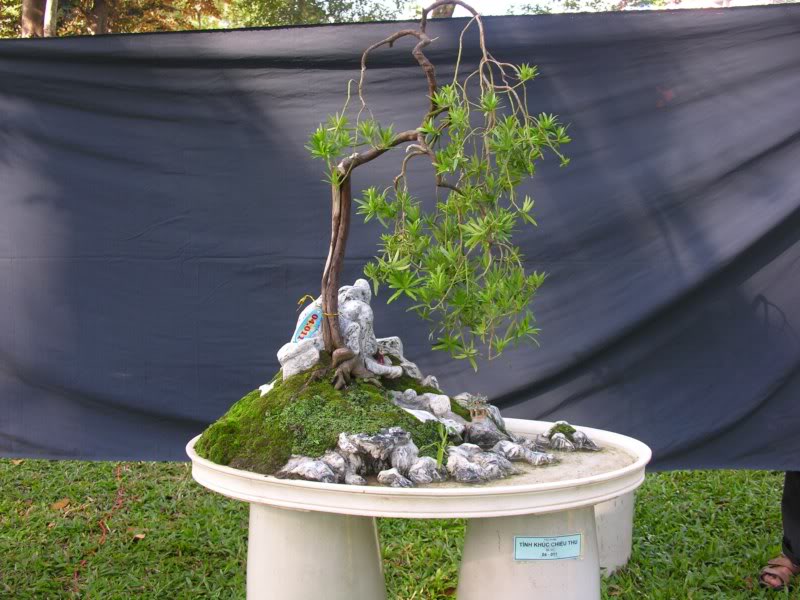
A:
[186, 419, 650, 600]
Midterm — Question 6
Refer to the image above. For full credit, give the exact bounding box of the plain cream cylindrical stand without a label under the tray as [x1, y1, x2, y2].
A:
[247, 504, 386, 600]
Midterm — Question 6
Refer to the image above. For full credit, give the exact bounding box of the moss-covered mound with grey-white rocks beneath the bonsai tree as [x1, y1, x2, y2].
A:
[196, 279, 600, 487]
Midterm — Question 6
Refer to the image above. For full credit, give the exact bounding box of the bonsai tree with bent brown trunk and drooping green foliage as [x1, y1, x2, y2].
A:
[307, 0, 570, 388]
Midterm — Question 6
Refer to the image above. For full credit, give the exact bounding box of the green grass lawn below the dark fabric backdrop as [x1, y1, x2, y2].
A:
[0, 460, 800, 600]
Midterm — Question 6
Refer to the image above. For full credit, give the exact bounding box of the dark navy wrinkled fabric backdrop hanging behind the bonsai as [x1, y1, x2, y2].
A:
[0, 5, 800, 470]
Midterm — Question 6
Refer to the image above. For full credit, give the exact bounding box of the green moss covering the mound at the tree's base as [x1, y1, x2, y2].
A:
[196, 373, 438, 474]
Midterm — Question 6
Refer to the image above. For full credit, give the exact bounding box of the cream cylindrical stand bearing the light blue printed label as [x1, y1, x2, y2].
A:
[457, 506, 600, 600]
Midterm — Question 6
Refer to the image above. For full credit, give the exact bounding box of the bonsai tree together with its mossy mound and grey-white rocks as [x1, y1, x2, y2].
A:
[196, 0, 588, 487]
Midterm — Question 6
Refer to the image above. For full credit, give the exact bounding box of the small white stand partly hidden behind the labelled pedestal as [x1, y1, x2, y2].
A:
[594, 492, 635, 576]
